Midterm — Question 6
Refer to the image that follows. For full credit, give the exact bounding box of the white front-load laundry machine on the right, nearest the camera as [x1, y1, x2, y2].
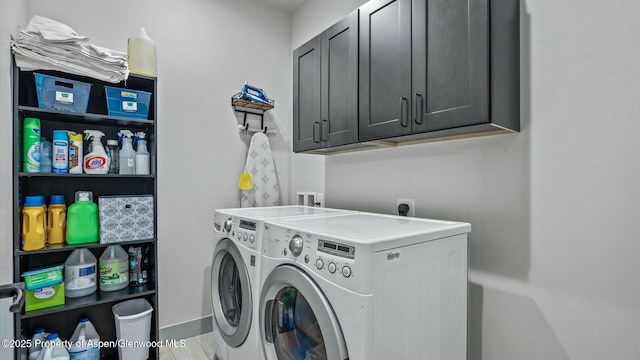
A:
[259, 213, 471, 360]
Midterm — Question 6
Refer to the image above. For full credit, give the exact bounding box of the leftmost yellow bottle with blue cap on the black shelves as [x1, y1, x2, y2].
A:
[21, 196, 45, 251]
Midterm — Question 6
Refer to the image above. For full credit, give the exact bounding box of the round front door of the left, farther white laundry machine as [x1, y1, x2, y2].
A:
[211, 238, 253, 347]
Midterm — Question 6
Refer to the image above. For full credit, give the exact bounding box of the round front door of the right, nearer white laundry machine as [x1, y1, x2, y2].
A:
[260, 265, 349, 360]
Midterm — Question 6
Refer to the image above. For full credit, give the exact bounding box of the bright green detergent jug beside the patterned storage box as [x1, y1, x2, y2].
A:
[67, 191, 100, 245]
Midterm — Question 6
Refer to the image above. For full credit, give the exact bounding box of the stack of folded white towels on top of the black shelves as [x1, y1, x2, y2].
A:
[11, 15, 129, 83]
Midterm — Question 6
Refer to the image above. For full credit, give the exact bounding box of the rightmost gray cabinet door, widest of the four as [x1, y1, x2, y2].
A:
[412, 0, 489, 132]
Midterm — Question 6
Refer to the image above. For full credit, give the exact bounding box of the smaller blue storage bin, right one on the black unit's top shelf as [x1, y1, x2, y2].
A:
[104, 86, 151, 119]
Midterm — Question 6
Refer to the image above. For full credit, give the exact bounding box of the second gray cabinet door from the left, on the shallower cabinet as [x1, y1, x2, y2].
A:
[321, 10, 358, 146]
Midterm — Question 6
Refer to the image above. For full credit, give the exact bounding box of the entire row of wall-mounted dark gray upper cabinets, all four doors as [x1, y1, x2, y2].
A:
[293, 0, 520, 153]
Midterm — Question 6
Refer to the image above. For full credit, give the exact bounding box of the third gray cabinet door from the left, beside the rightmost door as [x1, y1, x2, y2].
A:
[359, 0, 411, 141]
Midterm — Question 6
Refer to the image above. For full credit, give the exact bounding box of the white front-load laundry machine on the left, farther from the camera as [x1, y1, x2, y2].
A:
[211, 206, 352, 360]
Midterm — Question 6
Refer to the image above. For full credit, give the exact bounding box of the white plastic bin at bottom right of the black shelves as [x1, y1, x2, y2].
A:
[112, 299, 153, 360]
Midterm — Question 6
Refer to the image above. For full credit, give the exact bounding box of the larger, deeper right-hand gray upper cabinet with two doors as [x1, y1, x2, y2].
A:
[359, 0, 520, 143]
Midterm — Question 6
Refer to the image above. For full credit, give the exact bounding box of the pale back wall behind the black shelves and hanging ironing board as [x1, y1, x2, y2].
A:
[0, 0, 292, 327]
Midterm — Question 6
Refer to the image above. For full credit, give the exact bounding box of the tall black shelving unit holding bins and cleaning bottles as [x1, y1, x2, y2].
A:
[13, 65, 159, 359]
